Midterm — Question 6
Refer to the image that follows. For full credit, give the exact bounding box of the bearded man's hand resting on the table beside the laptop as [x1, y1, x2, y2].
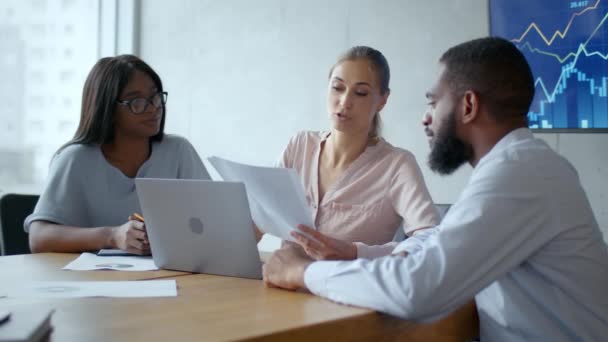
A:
[263, 244, 313, 290]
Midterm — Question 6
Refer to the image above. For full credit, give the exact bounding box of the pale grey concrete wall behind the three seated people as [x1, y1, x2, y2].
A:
[141, 0, 608, 251]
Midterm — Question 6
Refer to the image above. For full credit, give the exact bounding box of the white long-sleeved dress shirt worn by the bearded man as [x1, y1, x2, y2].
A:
[305, 128, 608, 341]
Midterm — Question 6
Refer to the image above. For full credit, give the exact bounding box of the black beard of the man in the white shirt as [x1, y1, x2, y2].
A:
[429, 112, 473, 175]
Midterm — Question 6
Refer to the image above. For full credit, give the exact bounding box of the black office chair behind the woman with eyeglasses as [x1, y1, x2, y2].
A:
[0, 194, 38, 255]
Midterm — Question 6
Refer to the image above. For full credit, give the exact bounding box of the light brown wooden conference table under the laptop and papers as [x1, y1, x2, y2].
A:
[0, 253, 478, 342]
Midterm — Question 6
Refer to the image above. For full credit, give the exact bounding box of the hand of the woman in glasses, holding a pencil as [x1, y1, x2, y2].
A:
[112, 214, 150, 255]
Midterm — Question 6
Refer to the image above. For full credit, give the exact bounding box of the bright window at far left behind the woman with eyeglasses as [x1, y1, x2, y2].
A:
[0, 0, 100, 193]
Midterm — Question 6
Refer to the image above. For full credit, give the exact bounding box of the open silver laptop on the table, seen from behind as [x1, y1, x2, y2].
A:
[135, 178, 262, 279]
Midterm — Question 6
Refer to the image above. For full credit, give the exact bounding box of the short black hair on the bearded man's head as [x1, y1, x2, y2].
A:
[439, 37, 534, 121]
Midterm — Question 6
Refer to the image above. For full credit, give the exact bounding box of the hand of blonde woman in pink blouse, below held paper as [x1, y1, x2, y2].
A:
[290, 225, 357, 260]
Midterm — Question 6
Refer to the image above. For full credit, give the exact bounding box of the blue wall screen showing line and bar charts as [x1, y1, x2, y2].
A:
[490, 0, 608, 130]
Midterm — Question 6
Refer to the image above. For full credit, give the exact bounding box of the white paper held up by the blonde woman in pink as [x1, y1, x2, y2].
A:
[207, 157, 315, 241]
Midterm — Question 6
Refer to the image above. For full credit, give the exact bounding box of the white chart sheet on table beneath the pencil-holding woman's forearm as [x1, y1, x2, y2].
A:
[63, 253, 158, 271]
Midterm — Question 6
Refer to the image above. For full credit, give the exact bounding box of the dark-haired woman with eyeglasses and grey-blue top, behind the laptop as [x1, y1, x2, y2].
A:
[24, 55, 209, 255]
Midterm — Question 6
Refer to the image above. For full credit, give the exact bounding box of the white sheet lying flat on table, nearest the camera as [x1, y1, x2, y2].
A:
[6, 280, 177, 298]
